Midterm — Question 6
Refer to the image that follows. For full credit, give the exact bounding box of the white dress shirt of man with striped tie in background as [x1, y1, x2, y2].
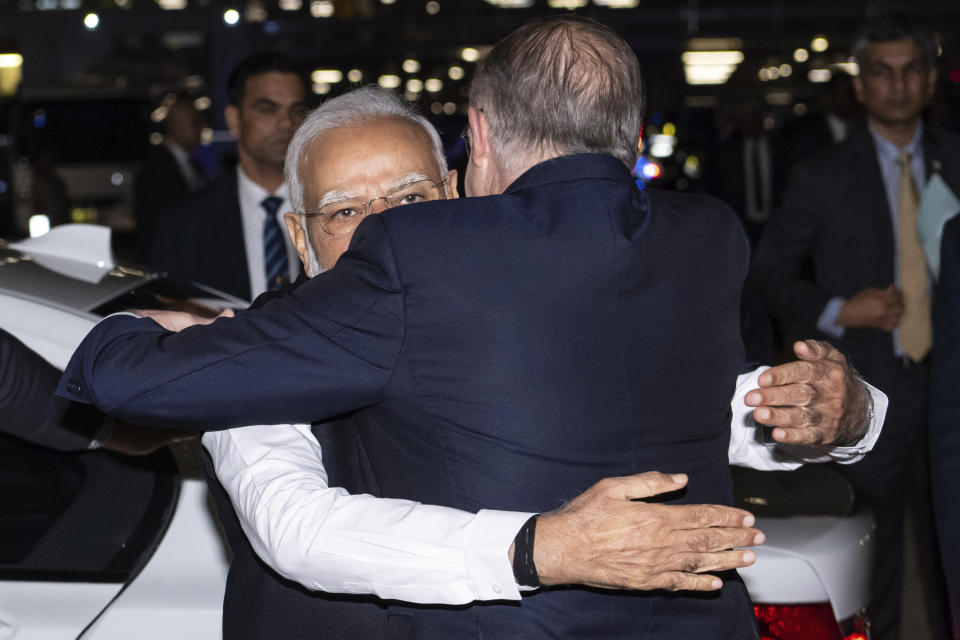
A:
[237, 166, 300, 300]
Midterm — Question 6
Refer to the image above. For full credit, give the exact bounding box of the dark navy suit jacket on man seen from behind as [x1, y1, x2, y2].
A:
[61, 154, 757, 638]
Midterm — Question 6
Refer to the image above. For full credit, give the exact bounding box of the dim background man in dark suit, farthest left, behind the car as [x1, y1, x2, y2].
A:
[134, 98, 206, 263]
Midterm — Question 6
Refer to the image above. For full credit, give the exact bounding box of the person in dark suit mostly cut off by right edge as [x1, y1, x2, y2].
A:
[930, 217, 960, 638]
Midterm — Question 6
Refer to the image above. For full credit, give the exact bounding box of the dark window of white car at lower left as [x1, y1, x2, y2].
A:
[0, 436, 179, 582]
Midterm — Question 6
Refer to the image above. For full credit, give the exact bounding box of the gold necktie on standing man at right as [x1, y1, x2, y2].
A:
[897, 152, 933, 362]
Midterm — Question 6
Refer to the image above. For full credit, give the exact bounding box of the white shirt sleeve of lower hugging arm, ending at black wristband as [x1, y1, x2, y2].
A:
[203, 424, 533, 605]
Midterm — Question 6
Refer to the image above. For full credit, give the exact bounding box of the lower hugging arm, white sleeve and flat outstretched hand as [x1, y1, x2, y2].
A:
[203, 425, 762, 604]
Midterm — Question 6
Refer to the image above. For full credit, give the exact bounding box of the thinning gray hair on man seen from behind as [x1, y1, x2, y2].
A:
[470, 15, 643, 172]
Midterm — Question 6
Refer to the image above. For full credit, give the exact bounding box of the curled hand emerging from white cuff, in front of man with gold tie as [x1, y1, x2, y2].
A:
[746, 340, 870, 446]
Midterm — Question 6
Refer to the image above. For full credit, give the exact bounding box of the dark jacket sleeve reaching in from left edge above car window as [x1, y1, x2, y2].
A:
[0, 331, 104, 451]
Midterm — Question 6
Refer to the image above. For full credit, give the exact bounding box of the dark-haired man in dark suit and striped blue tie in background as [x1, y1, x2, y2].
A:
[152, 53, 307, 300]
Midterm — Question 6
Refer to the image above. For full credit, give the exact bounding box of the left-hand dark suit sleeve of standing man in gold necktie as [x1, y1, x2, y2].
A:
[750, 164, 832, 331]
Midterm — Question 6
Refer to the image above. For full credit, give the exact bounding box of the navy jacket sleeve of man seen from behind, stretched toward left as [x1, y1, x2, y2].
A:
[58, 216, 404, 431]
